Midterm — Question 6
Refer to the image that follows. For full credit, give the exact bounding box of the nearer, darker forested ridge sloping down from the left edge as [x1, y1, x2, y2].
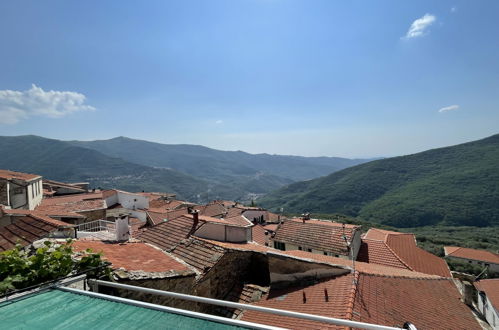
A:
[0, 136, 213, 198]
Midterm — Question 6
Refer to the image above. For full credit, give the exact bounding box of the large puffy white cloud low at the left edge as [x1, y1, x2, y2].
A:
[0, 84, 95, 124]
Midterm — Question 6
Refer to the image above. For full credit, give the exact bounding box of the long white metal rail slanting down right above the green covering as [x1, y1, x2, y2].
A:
[88, 280, 403, 330]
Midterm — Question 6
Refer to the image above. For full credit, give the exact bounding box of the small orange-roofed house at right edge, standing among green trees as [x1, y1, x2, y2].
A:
[444, 246, 499, 274]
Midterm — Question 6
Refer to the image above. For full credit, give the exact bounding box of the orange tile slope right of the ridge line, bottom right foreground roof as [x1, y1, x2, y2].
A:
[353, 274, 481, 330]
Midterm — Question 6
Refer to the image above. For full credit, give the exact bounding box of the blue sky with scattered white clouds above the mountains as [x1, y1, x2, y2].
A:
[0, 0, 499, 157]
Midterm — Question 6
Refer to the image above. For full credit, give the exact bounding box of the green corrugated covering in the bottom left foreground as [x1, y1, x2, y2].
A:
[0, 290, 248, 330]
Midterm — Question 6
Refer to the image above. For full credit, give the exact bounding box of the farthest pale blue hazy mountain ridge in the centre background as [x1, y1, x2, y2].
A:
[71, 137, 366, 182]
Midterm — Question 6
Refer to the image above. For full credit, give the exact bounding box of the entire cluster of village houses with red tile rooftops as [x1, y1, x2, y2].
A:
[0, 170, 499, 329]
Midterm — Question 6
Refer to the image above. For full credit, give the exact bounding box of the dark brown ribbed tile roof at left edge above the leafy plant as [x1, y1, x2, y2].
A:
[0, 215, 68, 251]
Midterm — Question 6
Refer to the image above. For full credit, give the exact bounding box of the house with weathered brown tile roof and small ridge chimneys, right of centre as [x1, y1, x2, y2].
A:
[270, 217, 361, 259]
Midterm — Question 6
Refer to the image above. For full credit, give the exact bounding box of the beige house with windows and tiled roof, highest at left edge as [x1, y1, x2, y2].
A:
[0, 170, 43, 210]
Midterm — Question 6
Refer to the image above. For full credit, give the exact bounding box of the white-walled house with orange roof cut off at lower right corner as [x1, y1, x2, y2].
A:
[475, 278, 499, 330]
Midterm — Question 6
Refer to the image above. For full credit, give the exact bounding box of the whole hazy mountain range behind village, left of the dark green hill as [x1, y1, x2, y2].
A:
[0, 135, 367, 202]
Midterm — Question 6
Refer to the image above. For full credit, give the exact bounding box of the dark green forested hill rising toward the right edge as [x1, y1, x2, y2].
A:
[259, 134, 499, 227]
